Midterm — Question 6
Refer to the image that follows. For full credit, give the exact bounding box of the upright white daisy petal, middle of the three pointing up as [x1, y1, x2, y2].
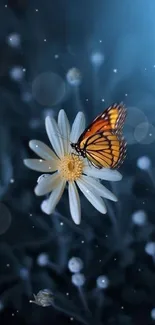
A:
[58, 109, 70, 153]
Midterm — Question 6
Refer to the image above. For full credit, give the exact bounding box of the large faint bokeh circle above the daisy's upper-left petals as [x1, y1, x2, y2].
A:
[32, 72, 66, 106]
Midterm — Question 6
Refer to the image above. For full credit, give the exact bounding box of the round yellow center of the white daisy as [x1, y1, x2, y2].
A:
[58, 154, 84, 182]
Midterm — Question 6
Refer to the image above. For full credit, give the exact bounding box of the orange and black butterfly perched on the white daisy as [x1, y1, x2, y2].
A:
[71, 103, 126, 168]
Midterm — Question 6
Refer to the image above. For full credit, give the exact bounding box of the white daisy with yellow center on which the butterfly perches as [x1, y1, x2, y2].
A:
[24, 110, 122, 225]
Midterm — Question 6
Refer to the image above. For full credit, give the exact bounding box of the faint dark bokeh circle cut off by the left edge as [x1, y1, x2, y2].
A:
[0, 202, 12, 235]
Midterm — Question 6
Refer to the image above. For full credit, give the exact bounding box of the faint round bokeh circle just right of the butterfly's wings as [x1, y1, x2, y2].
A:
[124, 107, 148, 145]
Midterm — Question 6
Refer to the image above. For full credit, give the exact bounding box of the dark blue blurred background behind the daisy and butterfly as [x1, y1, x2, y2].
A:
[0, 0, 155, 325]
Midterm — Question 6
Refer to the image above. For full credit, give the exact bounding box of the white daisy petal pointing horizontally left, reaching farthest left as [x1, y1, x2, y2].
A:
[24, 159, 57, 173]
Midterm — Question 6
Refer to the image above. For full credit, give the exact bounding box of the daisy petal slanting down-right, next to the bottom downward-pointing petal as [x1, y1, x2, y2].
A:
[76, 179, 107, 213]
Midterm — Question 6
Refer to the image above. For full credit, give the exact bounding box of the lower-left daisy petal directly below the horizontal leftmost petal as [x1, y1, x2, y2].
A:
[34, 173, 61, 196]
